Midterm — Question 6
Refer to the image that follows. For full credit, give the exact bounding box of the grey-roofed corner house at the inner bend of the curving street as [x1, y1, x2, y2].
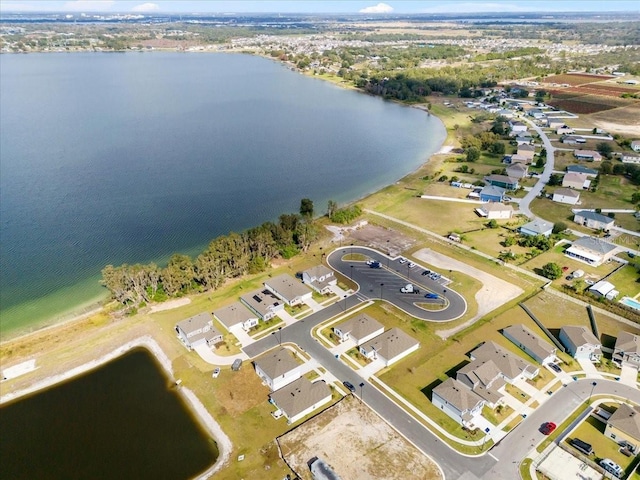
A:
[431, 378, 485, 427]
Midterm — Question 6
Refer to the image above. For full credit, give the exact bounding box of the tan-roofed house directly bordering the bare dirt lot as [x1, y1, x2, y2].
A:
[269, 377, 331, 423]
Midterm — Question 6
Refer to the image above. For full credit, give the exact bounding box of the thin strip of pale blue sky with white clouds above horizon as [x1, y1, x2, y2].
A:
[0, 0, 640, 14]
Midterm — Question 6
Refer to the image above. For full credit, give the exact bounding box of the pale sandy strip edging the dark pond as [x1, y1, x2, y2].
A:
[0, 336, 233, 479]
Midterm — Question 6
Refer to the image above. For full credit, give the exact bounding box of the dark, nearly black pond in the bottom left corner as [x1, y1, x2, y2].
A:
[0, 348, 218, 480]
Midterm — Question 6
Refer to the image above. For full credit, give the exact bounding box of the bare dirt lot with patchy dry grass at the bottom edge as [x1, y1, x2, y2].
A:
[280, 395, 443, 480]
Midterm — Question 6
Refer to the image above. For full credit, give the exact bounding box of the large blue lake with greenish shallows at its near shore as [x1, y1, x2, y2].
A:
[0, 52, 445, 338]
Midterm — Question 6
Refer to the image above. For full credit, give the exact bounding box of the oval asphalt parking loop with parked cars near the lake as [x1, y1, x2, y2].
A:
[327, 247, 467, 322]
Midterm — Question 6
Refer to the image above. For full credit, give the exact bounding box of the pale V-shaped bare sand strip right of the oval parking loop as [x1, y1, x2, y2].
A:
[413, 248, 524, 338]
